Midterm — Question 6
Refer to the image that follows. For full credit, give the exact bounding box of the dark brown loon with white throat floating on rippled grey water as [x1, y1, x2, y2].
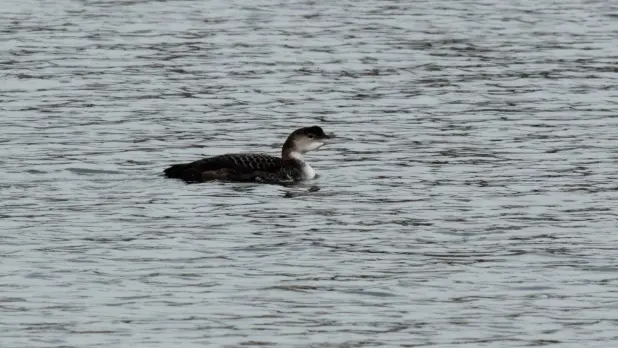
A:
[164, 126, 333, 185]
